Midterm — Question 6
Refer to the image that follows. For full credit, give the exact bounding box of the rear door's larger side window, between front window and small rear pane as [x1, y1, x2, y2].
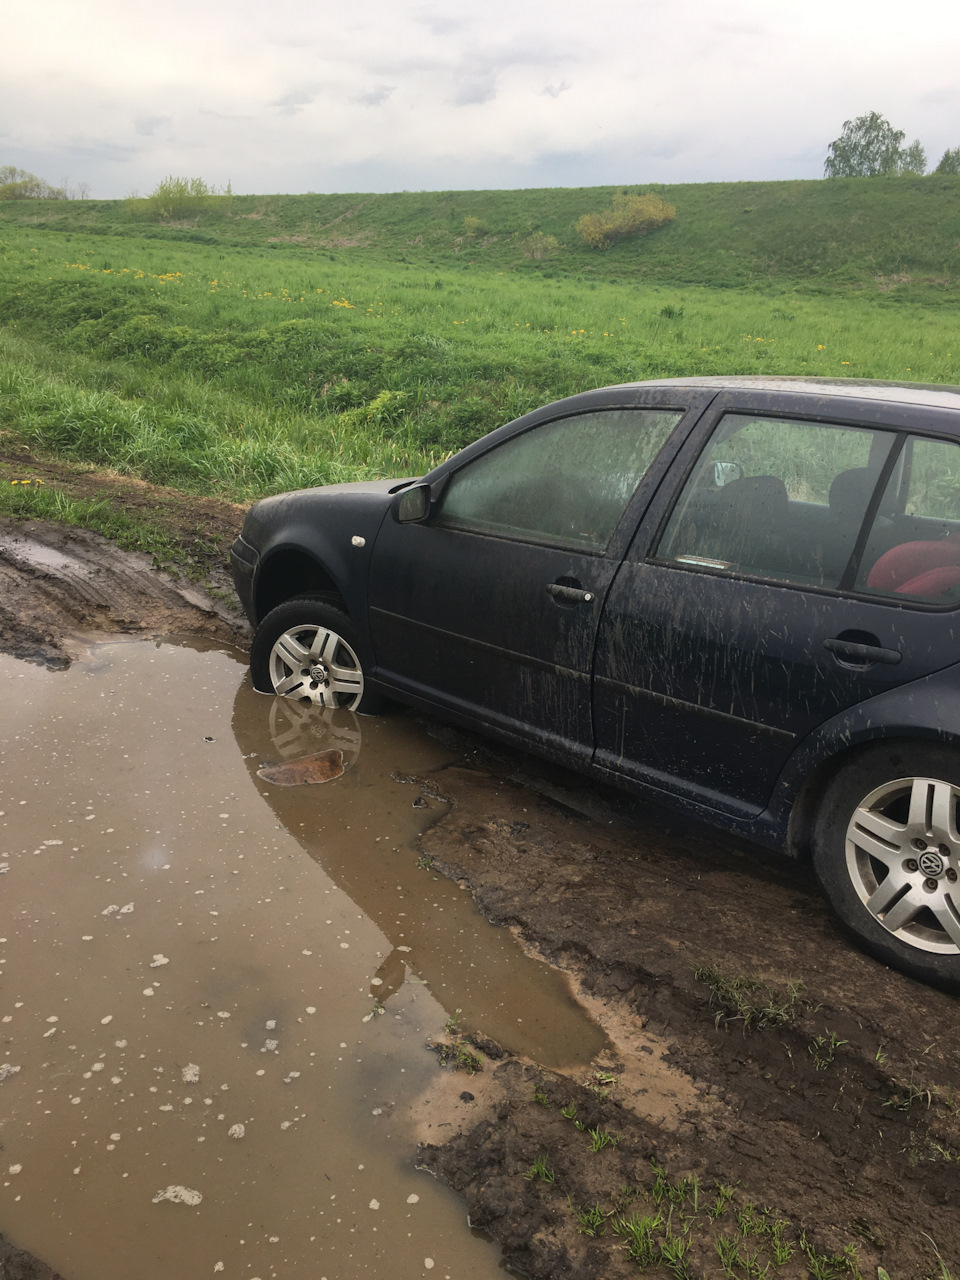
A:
[655, 413, 896, 588]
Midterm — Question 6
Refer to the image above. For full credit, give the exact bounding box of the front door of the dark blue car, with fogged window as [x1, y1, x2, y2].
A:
[369, 390, 712, 759]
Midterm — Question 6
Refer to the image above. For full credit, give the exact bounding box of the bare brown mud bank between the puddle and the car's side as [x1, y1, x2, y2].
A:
[421, 744, 960, 1277]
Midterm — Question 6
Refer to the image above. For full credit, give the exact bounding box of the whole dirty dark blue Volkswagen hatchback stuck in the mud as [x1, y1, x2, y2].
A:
[232, 378, 960, 984]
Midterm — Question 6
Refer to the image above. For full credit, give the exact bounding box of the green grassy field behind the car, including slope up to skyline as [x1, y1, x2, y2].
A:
[0, 178, 960, 500]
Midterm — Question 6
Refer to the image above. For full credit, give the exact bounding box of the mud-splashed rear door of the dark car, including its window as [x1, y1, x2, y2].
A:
[595, 394, 960, 813]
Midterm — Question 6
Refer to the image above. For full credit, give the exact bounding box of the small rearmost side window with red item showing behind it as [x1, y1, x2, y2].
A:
[856, 436, 960, 604]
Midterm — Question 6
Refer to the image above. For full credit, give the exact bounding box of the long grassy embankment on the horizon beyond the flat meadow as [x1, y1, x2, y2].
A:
[0, 175, 960, 295]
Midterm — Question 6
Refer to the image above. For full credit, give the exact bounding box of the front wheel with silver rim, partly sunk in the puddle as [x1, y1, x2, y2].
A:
[250, 598, 381, 716]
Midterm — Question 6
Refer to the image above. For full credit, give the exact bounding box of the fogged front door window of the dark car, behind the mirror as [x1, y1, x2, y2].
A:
[435, 408, 684, 550]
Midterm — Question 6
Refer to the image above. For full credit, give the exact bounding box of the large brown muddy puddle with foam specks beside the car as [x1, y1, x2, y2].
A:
[0, 641, 603, 1280]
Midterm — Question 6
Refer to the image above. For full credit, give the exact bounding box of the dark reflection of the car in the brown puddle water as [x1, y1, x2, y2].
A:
[233, 682, 605, 1066]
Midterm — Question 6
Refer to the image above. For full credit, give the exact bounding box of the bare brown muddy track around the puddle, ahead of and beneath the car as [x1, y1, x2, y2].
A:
[0, 460, 960, 1280]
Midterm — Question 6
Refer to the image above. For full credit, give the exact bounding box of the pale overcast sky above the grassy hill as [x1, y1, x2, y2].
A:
[0, 0, 960, 197]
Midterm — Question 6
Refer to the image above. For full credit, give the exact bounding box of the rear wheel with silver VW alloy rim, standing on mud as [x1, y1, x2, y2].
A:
[813, 742, 960, 991]
